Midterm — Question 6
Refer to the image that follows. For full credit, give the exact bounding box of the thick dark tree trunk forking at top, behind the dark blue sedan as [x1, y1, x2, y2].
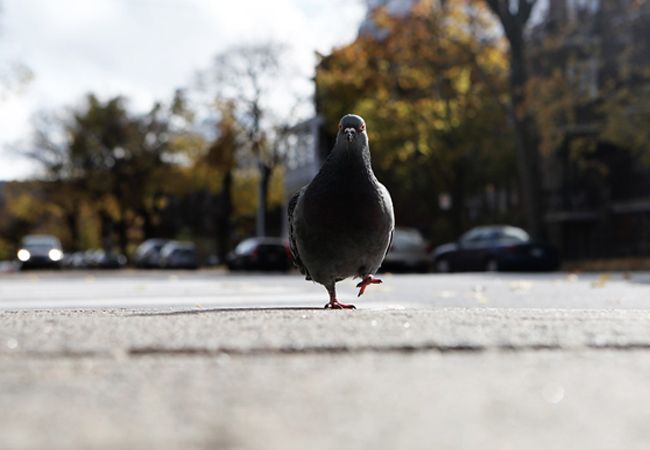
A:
[485, 0, 543, 237]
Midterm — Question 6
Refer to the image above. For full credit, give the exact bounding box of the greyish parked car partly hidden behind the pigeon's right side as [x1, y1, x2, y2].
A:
[381, 228, 429, 272]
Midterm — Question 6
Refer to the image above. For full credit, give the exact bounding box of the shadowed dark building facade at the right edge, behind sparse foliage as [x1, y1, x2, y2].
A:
[530, 0, 650, 259]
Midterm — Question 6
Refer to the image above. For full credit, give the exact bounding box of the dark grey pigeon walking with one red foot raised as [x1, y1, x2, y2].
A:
[288, 114, 395, 309]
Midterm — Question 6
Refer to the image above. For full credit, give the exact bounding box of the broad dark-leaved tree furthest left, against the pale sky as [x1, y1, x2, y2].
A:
[25, 95, 177, 253]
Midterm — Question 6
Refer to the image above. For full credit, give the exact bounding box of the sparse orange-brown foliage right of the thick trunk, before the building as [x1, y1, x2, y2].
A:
[527, 2, 650, 211]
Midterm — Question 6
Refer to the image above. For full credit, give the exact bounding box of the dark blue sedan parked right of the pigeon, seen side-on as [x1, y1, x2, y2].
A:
[433, 225, 559, 272]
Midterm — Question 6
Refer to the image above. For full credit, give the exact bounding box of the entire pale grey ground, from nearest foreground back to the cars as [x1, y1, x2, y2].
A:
[0, 272, 650, 450]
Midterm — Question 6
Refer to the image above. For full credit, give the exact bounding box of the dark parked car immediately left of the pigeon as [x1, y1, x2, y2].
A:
[227, 237, 291, 271]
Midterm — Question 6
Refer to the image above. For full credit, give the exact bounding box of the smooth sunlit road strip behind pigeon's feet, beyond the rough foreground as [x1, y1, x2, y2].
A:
[0, 270, 650, 309]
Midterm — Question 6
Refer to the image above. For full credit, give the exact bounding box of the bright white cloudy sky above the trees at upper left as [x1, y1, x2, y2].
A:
[0, 0, 365, 180]
